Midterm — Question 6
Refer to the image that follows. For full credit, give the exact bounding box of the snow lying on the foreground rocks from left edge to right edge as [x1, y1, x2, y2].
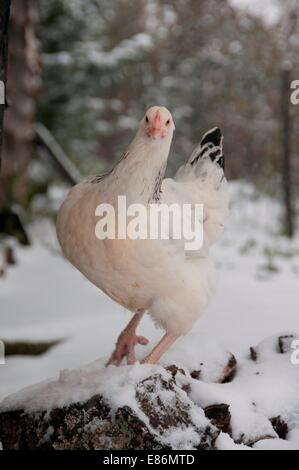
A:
[0, 328, 299, 450]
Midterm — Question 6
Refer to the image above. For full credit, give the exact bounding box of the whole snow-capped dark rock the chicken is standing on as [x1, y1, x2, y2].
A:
[0, 363, 219, 450]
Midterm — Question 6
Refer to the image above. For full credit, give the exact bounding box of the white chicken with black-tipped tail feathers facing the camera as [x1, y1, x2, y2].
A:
[57, 106, 228, 365]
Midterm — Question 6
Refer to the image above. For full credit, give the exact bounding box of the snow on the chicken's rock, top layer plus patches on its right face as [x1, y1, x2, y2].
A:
[0, 361, 209, 449]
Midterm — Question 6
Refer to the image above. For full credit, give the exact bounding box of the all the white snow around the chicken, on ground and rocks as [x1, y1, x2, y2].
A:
[0, 184, 299, 449]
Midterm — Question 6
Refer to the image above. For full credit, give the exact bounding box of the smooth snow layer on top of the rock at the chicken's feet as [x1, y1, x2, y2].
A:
[0, 361, 161, 412]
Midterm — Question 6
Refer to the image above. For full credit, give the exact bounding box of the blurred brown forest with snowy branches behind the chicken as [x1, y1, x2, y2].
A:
[0, 0, 299, 264]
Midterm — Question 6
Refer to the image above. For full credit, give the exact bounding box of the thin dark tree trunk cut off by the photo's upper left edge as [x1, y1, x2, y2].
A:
[0, 0, 10, 169]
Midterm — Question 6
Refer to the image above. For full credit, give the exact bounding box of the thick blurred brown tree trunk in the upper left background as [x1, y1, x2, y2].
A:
[0, 0, 40, 211]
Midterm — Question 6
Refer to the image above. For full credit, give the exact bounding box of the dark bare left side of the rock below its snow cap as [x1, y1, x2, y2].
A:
[0, 396, 159, 450]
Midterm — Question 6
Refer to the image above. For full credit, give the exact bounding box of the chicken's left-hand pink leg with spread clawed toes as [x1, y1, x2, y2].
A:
[106, 310, 148, 367]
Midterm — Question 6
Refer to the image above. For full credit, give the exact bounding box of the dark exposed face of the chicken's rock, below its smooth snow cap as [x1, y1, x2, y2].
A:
[0, 374, 220, 450]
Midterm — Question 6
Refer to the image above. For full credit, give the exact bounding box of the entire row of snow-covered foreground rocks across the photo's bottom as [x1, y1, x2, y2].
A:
[0, 332, 299, 450]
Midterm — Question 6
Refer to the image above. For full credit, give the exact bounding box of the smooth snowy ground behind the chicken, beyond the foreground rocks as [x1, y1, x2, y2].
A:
[0, 184, 299, 414]
